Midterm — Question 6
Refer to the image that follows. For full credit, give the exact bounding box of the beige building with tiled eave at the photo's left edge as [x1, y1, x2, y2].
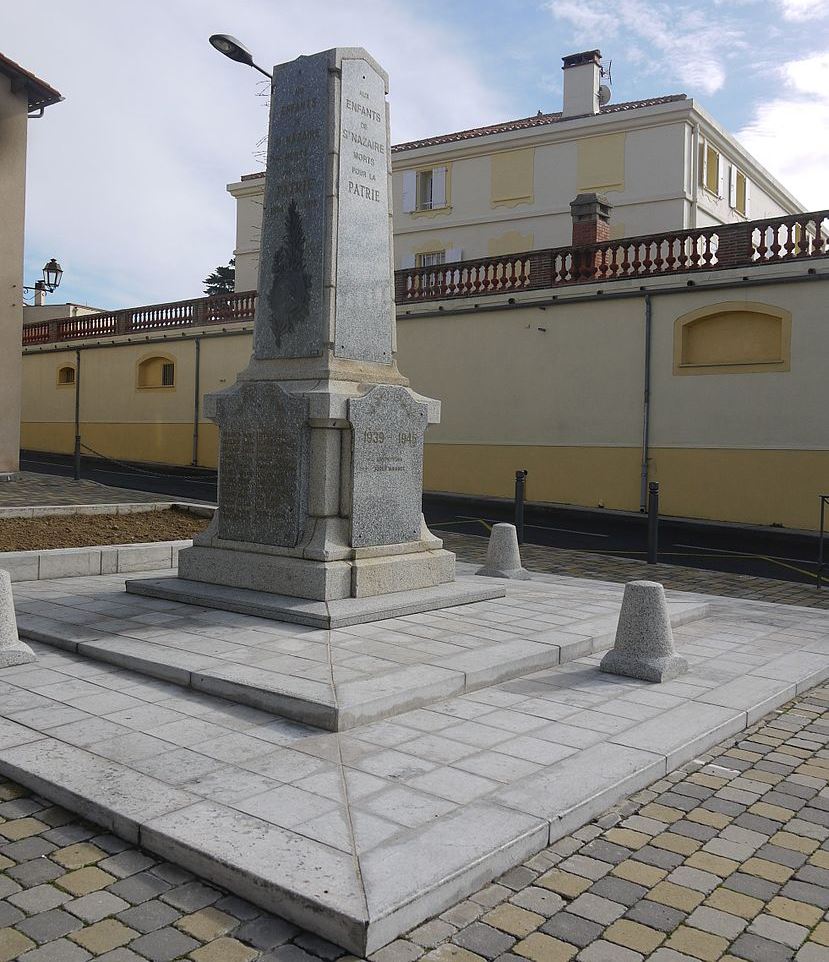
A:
[0, 54, 62, 478]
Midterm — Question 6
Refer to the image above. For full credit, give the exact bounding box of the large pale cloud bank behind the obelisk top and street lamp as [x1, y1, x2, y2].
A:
[0, 0, 509, 307]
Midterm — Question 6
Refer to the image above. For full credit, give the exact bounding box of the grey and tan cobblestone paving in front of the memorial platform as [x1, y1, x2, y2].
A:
[0, 686, 829, 962]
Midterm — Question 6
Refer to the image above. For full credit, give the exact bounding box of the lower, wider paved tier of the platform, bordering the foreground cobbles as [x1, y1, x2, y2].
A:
[0, 578, 829, 958]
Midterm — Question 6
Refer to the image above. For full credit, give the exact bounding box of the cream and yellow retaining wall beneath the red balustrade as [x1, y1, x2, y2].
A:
[23, 261, 829, 528]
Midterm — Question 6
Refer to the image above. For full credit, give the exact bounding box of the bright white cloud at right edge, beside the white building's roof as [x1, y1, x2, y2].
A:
[737, 50, 829, 210]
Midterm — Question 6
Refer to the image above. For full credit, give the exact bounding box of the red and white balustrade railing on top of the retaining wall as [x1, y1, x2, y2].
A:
[23, 210, 829, 347]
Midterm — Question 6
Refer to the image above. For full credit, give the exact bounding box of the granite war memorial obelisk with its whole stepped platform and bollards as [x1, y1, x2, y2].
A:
[0, 48, 829, 955]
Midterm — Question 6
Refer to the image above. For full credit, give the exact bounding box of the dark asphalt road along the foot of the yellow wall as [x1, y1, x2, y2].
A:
[21, 453, 829, 584]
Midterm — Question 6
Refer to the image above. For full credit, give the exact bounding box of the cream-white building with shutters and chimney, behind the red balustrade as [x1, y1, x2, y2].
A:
[228, 50, 804, 291]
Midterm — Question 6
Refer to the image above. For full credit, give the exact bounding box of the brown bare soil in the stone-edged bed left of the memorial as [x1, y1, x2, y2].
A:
[0, 508, 210, 551]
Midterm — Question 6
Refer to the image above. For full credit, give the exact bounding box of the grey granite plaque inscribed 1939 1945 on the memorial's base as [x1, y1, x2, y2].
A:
[348, 385, 428, 548]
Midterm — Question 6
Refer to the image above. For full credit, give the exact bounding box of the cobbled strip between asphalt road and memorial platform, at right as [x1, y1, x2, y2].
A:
[437, 531, 829, 608]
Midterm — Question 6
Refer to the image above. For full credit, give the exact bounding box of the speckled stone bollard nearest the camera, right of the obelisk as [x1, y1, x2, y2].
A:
[601, 581, 688, 682]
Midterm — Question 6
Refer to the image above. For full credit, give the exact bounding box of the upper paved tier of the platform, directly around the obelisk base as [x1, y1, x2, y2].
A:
[15, 566, 707, 731]
